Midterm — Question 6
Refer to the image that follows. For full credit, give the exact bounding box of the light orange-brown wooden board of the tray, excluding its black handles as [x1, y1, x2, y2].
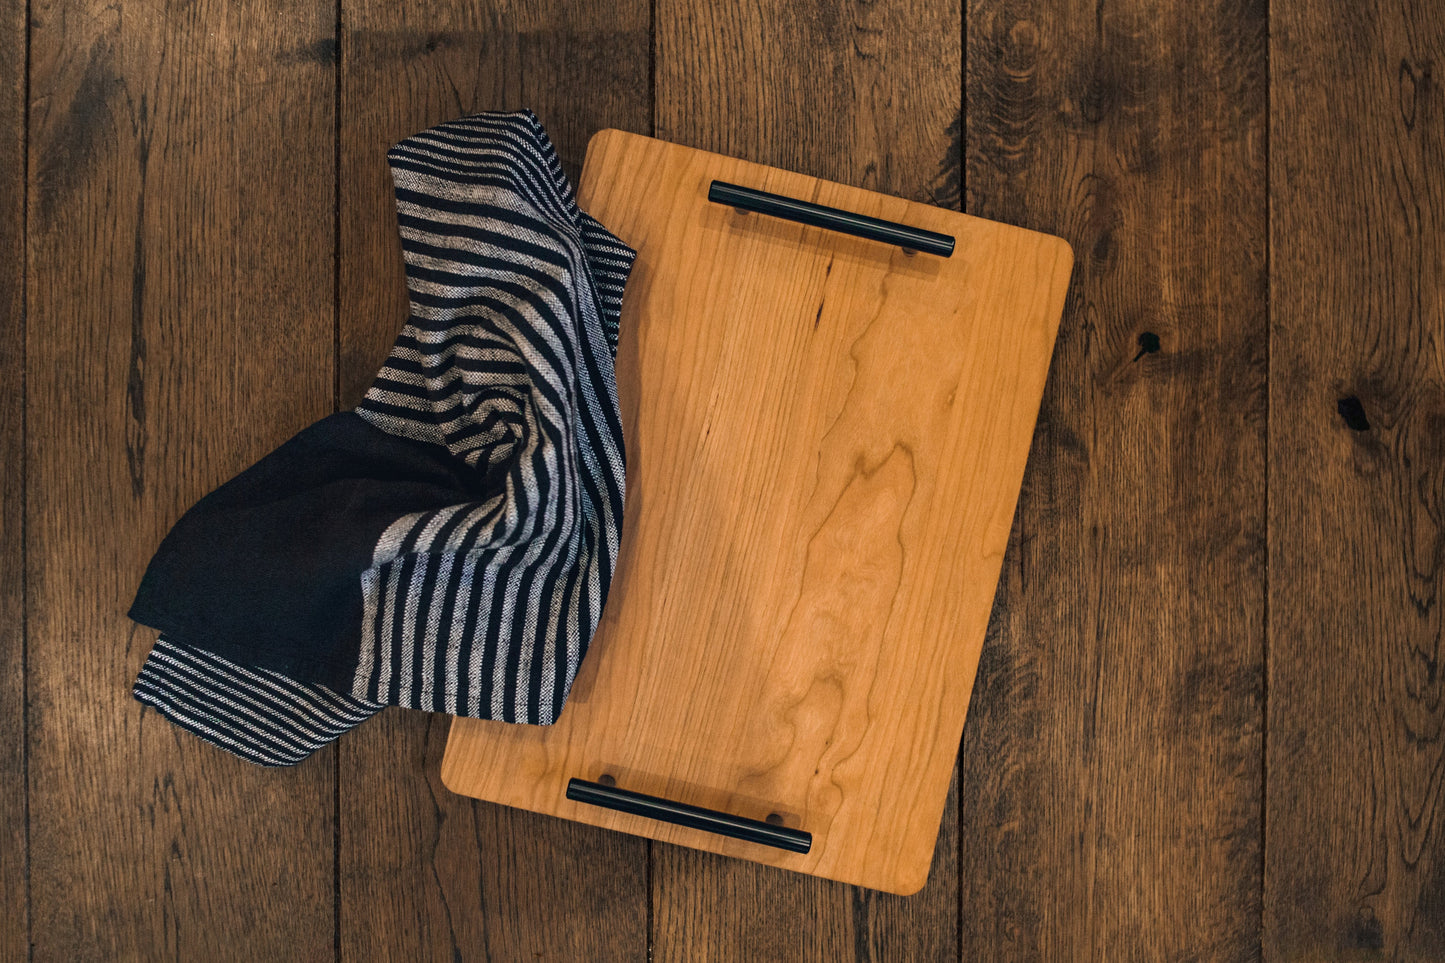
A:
[442, 130, 1072, 894]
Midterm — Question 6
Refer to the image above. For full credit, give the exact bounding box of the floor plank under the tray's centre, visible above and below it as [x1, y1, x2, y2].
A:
[652, 0, 962, 942]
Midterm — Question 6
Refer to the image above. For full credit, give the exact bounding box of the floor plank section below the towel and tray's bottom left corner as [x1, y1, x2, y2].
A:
[340, 710, 647, 963]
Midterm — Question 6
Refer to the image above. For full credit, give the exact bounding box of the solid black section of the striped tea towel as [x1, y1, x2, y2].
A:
[129, 412, 506, 691]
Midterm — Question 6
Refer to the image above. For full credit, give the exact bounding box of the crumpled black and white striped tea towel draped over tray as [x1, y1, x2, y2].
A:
[130, 111, 634, 765]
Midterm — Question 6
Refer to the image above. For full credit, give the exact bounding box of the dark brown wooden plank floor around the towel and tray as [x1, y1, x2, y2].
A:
[0, 0, 1445, 962]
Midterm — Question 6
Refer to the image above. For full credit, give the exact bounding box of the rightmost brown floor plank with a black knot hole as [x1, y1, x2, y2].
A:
[1264, 0, 1445, 960]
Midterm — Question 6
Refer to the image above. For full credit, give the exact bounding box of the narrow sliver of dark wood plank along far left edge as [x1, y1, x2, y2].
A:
[0, 3, 29, 960]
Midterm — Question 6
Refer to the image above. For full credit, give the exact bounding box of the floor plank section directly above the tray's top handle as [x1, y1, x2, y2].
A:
[656, 0, 962, 201]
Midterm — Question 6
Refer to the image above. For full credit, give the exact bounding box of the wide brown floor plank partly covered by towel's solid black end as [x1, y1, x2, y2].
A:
[27, 0, 335, 962]
